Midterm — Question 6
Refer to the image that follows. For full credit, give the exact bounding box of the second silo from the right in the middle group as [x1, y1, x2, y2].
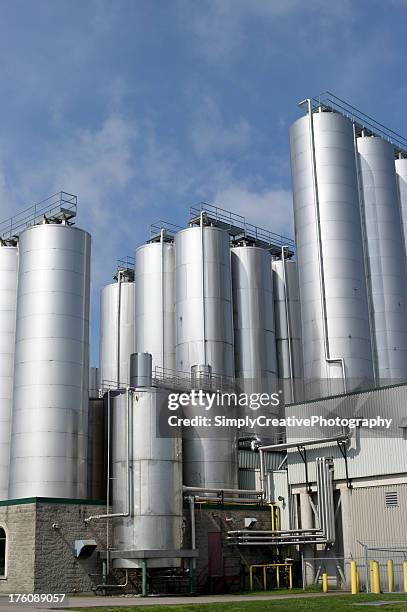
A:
[231, 246, 277, 393]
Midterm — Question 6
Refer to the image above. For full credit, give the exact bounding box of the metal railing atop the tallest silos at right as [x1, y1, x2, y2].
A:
[298, 91, 407, 156]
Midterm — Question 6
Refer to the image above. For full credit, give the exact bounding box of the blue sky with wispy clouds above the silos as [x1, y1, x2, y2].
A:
[0, 0, 407, 364]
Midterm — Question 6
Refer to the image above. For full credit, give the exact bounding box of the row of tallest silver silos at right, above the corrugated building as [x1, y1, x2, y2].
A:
[290, 104, 407, 397]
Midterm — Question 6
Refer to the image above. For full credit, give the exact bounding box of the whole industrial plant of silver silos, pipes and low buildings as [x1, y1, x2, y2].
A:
[0, 92, 407, 595]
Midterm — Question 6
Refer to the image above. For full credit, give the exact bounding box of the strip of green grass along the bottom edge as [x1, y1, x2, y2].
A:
[71, 593, 407, 612]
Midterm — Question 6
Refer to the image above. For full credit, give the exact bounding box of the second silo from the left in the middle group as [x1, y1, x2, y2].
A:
[135, 239, 175, 373]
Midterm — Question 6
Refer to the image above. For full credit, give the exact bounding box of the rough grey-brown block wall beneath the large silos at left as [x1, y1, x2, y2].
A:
[0, 498, 106, 594]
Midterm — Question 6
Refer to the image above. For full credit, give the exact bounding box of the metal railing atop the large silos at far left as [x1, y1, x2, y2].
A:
[0, 191, 78, 240]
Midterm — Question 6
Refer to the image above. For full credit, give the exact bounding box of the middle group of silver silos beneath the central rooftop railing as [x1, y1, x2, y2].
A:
[100, 220, 301, 490]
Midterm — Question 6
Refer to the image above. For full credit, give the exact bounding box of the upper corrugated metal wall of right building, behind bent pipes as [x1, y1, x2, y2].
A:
[286, 385, 407, 484]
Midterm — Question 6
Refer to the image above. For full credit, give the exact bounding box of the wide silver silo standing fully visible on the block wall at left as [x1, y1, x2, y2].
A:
[9, 224, 90, 499]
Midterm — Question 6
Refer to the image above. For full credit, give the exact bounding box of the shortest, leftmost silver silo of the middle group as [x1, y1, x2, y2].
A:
[99, 271, 135, 387]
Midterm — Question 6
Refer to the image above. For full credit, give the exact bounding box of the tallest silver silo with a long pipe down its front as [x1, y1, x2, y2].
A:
[290, 107, 373, 397]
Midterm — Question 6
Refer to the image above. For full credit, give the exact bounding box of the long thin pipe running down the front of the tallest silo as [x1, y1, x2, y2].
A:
[307, 98, 347, 393]
